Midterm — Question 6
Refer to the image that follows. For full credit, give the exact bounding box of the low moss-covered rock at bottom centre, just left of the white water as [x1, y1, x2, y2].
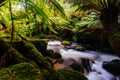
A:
[58, 69, 88, 80]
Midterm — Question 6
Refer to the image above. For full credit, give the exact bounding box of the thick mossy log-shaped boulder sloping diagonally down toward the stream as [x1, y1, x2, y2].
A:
[13, 41, 49, 68]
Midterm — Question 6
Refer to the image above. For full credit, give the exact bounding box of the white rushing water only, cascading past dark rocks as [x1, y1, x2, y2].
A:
[47, 40, 120, 80]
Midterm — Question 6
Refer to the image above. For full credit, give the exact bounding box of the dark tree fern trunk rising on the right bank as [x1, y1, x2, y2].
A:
[100, 10, 120, 57]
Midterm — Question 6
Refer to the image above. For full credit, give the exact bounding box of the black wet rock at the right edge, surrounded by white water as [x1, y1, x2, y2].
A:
[102, 59, 120, 76]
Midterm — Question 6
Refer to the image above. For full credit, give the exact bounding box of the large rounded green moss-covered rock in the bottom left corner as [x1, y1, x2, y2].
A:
[0, 63, 43, 80]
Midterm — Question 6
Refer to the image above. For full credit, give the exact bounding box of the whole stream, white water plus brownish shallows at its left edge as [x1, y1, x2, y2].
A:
[47, 40, 120, 80]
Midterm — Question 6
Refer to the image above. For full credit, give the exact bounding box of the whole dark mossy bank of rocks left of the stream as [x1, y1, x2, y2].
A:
[0, 40, 87, 80]
